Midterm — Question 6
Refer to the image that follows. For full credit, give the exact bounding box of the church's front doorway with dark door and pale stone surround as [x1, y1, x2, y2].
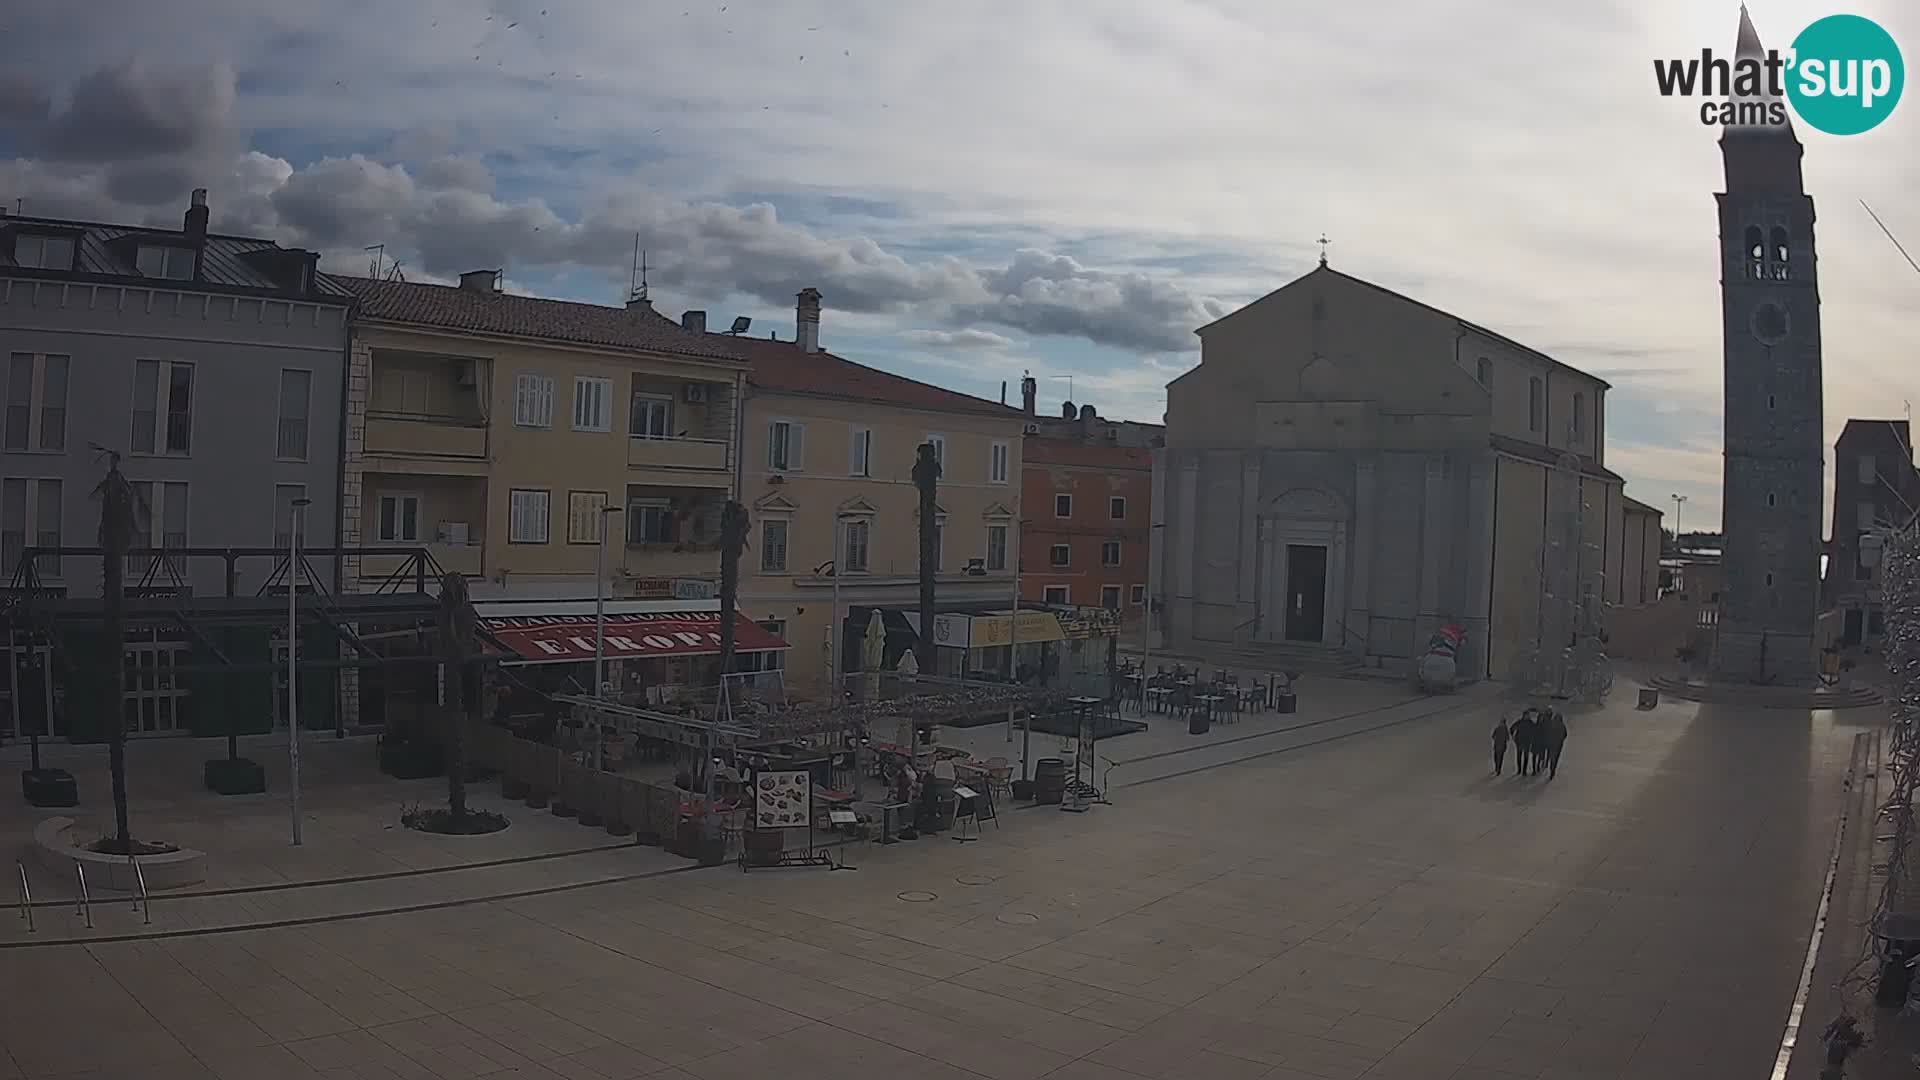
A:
[1258, 488, 1348, 648]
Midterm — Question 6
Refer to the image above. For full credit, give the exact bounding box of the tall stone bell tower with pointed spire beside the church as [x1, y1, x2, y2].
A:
[1713, 8, 1826, 686]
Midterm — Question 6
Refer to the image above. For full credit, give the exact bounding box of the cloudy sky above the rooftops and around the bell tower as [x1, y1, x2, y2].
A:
[0, 0, 1920, 528]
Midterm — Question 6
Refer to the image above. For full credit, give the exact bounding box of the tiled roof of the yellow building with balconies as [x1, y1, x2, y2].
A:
[334, 277, 741, 361]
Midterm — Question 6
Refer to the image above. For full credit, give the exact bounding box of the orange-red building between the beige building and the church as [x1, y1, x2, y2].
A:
[1020, 434, 1154, 619]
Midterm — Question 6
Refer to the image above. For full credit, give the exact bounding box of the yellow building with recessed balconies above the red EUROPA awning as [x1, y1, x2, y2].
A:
[342, 271, 779, 711]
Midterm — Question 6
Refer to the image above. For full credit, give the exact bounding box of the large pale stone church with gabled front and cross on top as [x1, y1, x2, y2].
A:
[1154, 261, 1640, 678]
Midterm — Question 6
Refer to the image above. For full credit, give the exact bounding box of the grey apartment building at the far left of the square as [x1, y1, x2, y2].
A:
[0, 190, 351, 734]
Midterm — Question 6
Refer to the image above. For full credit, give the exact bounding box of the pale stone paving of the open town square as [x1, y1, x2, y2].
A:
[0, 684, 1882, 1080]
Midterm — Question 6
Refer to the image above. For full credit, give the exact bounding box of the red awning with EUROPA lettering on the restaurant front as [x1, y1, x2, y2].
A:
[480, 611, 787, 663]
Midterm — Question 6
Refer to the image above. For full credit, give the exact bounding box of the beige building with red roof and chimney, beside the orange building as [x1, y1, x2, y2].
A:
[710, 290, 1025, 690]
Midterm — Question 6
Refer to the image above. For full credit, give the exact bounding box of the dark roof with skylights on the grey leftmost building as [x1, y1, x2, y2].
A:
[0, 215, 351, 302]
